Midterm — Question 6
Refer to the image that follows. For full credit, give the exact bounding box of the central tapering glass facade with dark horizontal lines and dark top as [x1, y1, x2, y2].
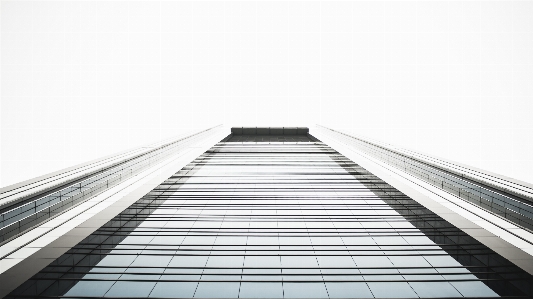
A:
[4, 128, 532, 298]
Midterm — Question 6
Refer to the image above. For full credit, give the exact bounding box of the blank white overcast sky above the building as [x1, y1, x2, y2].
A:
[0, 1, 533, 186]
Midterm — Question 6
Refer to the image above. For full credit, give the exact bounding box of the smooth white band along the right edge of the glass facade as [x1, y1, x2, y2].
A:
[310, 125, 533, 274]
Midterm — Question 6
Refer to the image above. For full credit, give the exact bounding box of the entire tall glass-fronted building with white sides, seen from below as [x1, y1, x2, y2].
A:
[0, 126, 533, 298]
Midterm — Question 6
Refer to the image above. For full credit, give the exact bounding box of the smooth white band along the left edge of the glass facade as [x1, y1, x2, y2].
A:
[0, 125, 227, 298]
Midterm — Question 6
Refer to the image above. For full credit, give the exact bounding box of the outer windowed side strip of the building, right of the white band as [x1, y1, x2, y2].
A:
[318, 126, 533, 230]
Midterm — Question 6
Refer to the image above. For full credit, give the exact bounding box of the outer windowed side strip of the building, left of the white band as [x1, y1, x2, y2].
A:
[0, 126, 219, 243]
